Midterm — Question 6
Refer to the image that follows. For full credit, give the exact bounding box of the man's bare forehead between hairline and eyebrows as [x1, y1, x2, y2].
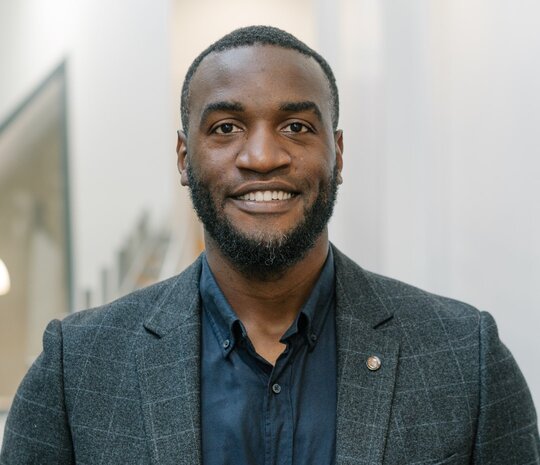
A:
[189, 45, 331, 123]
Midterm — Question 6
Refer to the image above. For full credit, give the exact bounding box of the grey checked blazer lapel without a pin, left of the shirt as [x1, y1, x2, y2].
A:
[136, 258, 201, 465]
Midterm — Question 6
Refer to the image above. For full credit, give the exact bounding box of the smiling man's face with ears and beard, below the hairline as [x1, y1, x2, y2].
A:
[178, 46, 342, 277]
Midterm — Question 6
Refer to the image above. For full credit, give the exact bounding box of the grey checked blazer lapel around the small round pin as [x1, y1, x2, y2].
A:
[334, 245, 399, 465]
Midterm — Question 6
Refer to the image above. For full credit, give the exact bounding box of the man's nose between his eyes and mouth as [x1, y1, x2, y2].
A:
[236, 126, 291, 173]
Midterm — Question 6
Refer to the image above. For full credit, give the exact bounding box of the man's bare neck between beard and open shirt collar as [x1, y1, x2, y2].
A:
[205, 230, 329, 363]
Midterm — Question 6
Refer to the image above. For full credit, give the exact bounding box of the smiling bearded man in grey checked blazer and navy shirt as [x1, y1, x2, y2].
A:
[1, 27, 540, 465]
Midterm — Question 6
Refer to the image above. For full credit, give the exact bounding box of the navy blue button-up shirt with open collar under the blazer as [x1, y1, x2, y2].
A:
[200, 250, 337, 465]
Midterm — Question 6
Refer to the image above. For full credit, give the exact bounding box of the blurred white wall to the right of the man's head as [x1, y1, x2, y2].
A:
[319, 0, 540, 406]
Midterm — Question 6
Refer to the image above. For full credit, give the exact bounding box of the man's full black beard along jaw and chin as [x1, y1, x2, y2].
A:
[187, 167, 338, 281]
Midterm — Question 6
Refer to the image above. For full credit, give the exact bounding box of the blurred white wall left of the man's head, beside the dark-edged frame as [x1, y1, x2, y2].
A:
[0, 0, 176, 304]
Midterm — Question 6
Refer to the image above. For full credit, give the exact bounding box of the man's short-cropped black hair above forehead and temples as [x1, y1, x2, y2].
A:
[184, 26, 339, 134]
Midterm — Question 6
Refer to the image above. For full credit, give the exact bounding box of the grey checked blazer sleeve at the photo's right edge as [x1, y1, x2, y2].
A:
[474, 312, 540, 465]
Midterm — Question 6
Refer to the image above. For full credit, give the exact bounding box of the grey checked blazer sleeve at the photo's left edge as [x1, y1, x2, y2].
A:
[0, 320, 75, 465]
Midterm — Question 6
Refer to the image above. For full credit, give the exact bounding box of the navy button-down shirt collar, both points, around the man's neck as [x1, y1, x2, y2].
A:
[199, 248, 335, 357]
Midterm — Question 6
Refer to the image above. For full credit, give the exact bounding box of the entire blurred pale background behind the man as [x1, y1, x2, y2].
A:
[0, 0, 540, 434]
